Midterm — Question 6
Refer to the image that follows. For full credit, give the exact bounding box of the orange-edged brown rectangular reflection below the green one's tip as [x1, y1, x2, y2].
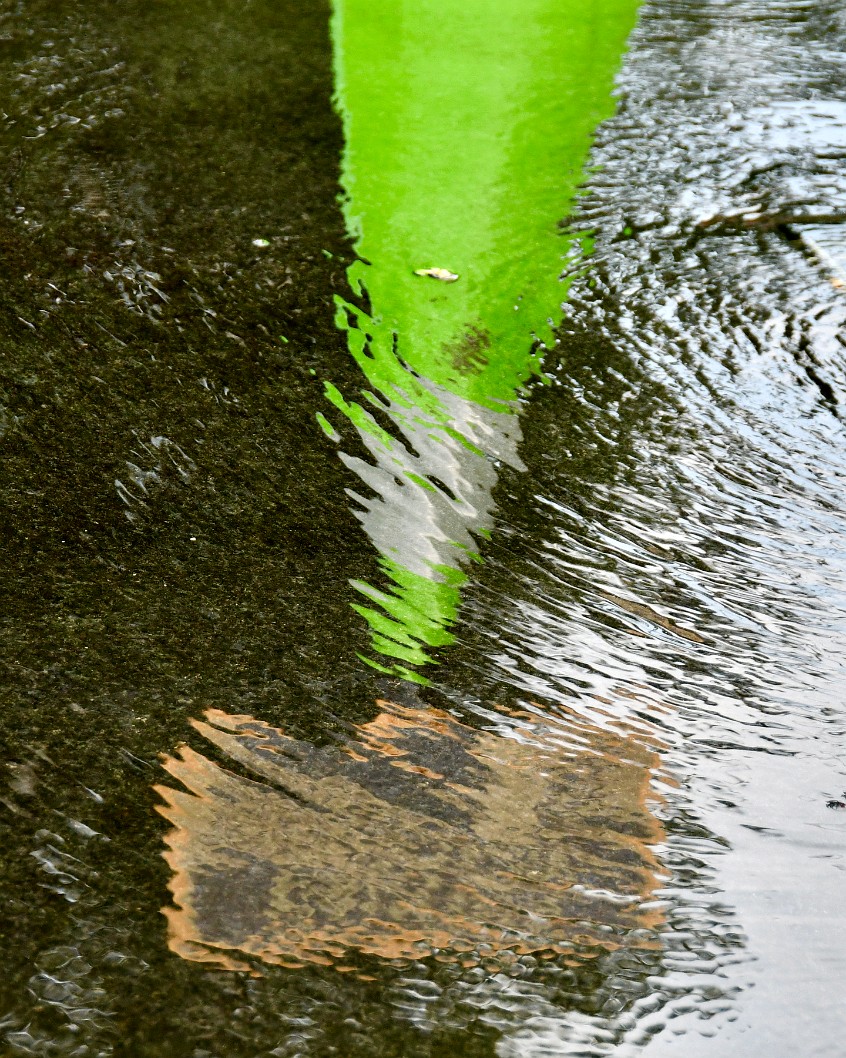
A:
[158, 703, 660, 968]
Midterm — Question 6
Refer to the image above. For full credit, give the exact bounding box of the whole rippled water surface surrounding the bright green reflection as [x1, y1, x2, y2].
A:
[0, 0, 846, 1058]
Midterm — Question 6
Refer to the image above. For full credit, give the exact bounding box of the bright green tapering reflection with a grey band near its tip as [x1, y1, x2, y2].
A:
[325, 0, 638, 680]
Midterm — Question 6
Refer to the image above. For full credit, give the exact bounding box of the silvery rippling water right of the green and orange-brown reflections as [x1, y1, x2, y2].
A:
[439, 4, 846, 1055]
